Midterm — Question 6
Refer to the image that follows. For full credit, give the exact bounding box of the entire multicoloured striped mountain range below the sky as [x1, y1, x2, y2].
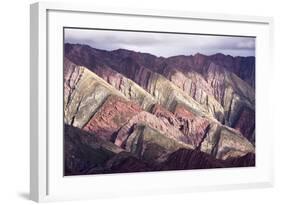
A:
[64, 44, 255, 175]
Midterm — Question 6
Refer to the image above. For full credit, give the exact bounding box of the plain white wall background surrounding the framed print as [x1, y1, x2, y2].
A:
[0, 0, 281, 205]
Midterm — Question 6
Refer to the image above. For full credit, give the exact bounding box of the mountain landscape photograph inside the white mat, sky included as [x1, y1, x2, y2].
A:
[61, 27, 256, 176]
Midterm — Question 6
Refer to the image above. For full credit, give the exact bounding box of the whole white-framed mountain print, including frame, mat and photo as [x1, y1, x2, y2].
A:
[30, 3, 273, 201]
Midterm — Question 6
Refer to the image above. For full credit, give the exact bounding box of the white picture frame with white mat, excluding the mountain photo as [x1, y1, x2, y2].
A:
[30, 2, 274, 202]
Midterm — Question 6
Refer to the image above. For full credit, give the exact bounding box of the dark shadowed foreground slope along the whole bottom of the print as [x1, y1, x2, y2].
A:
[64, 125, 255, 176]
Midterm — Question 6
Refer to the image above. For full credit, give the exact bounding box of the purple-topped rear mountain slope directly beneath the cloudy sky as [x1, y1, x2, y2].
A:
[65, 44, 255, 139]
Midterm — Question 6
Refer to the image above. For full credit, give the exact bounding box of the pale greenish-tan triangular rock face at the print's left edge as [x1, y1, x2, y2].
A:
[64, 59, 124, 128]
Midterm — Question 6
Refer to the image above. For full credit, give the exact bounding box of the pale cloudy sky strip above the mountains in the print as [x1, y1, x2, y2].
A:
[64, 28, 255, 57]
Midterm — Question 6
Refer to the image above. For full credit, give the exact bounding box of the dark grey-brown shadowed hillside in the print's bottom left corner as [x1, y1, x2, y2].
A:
[64, 125, 123, 175]
